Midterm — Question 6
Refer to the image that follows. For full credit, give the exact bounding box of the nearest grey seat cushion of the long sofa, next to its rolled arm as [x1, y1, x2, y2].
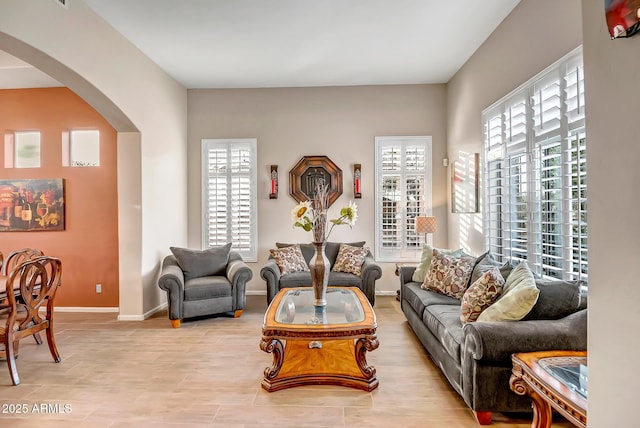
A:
[422, 305, 464, 361]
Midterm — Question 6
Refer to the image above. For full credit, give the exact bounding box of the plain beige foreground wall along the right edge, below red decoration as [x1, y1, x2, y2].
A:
[582, 0, 640, 427]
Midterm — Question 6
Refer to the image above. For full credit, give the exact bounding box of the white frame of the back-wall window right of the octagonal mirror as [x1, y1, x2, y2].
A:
[375, 135, 433, 262]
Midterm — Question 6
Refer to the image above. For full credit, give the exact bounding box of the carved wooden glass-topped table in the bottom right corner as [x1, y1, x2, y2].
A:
[509, 351, 587, 428]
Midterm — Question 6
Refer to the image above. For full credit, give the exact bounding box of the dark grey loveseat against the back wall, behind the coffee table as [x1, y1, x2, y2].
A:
[260, 242, 382, 306]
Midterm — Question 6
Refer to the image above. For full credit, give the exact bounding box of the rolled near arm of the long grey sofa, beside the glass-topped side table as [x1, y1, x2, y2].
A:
[463, 309, 587, 361]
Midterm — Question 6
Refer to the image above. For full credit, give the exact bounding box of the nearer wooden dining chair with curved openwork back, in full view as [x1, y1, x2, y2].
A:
[0, 256, 62, 385]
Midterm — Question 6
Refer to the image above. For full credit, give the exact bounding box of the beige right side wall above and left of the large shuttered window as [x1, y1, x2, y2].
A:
[447, 0, 582, 254]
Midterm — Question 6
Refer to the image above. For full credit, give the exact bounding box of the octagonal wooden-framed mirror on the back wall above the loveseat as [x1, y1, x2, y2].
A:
[289, 156, 342, 206]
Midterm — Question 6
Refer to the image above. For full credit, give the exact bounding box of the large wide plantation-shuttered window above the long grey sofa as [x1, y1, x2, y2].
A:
[483, 48, 588, 280]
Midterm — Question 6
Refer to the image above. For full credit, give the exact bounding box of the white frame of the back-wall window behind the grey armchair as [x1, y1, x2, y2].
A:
[201, 138, 258, 262]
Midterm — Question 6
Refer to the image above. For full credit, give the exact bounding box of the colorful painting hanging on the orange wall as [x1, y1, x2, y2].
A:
[0, 178, 64, 232]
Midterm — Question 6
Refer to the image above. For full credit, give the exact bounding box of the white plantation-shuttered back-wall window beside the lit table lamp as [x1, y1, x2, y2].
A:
[375, 137, 431, 262]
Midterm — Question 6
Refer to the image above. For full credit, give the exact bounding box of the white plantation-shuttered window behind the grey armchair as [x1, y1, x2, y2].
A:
[202, 139, 258, 261]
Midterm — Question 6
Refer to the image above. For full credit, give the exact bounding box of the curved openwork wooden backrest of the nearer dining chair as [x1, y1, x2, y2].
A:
[7, 256, 62, 335]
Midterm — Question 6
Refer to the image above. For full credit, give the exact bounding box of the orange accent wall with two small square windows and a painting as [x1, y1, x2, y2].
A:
[0, 88, 118, 307]
